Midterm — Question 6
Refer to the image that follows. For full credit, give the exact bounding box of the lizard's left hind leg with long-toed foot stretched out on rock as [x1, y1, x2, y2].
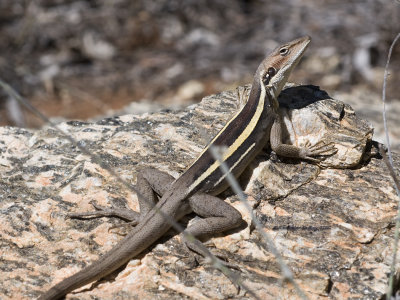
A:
[68, 168, 175, 225]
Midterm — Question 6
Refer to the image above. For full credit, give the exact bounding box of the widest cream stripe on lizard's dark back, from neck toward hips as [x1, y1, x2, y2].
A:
[188, 84, 266, 193]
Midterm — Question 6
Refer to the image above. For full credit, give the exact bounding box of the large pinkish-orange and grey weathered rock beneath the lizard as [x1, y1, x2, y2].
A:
[0, 86, 400, 299]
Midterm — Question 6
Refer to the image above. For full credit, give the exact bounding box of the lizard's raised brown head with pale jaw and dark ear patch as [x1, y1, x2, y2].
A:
[256, 36, 311, 100]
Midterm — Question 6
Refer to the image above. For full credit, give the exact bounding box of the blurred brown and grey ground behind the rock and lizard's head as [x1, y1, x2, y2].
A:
[0, 0, 400, 148]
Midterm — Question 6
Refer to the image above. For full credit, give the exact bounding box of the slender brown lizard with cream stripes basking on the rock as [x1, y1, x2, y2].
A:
[39, 36, 335, 300]
